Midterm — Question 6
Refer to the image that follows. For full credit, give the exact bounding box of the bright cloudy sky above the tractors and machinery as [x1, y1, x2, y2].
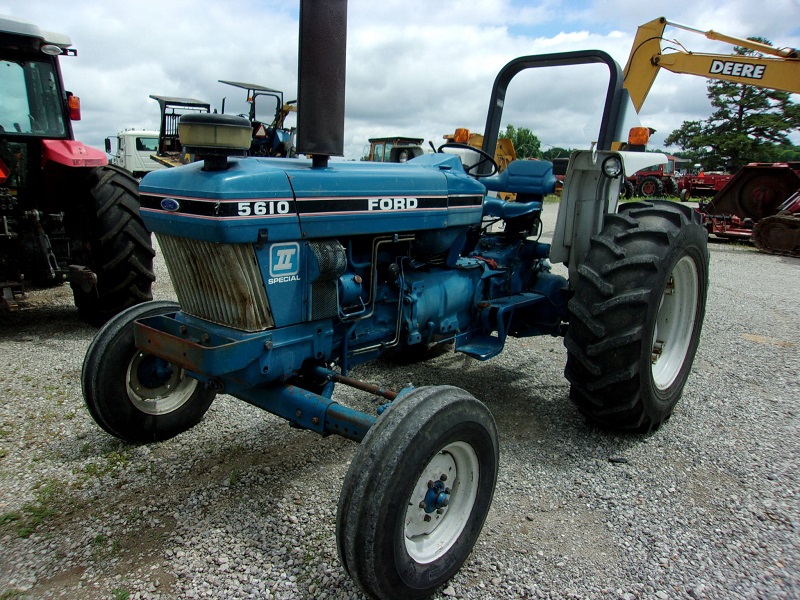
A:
[0, 0, 800, 158]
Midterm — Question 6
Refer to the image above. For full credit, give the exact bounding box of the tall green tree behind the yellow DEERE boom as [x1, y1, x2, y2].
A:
[665, 37, 800, 172]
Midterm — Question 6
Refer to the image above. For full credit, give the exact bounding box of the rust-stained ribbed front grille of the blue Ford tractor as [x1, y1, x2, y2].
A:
[156, 233, 275, 331]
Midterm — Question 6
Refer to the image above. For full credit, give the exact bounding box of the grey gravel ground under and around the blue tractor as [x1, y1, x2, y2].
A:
[0, 211, 800, 600]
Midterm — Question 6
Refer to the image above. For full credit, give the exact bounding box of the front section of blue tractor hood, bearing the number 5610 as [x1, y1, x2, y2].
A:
[139, 159, 300, 244]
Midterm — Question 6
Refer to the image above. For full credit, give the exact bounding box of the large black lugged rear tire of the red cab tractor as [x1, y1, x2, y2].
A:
[70, 165, 155, 325]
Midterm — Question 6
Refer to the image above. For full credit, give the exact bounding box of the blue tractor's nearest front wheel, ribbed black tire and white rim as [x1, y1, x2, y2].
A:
[336, 386, 499, 600]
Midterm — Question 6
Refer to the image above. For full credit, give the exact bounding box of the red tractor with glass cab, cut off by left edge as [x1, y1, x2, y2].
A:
[0, 17, 155, 323]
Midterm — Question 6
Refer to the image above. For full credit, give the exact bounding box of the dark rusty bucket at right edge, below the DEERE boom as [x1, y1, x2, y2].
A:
[703, 163, 800, 222]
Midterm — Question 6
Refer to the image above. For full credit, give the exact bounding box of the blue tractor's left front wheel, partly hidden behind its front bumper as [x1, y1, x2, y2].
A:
[81, 300, 214, 442]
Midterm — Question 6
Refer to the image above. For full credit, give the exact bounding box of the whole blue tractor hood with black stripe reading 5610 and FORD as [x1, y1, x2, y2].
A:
[139, 154, 486, 243]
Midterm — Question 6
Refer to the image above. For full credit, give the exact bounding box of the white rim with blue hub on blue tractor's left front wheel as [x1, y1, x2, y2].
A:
[125, 352, 198, 415]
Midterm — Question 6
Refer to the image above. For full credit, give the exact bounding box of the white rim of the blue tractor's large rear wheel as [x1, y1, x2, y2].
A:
[650, 256, 699, 390]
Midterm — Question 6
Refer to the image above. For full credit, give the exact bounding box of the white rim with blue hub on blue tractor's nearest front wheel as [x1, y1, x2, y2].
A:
[404, 442, 480, 564]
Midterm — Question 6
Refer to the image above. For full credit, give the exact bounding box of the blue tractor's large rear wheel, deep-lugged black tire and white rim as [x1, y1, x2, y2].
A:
[564, 200, 709, 432]
